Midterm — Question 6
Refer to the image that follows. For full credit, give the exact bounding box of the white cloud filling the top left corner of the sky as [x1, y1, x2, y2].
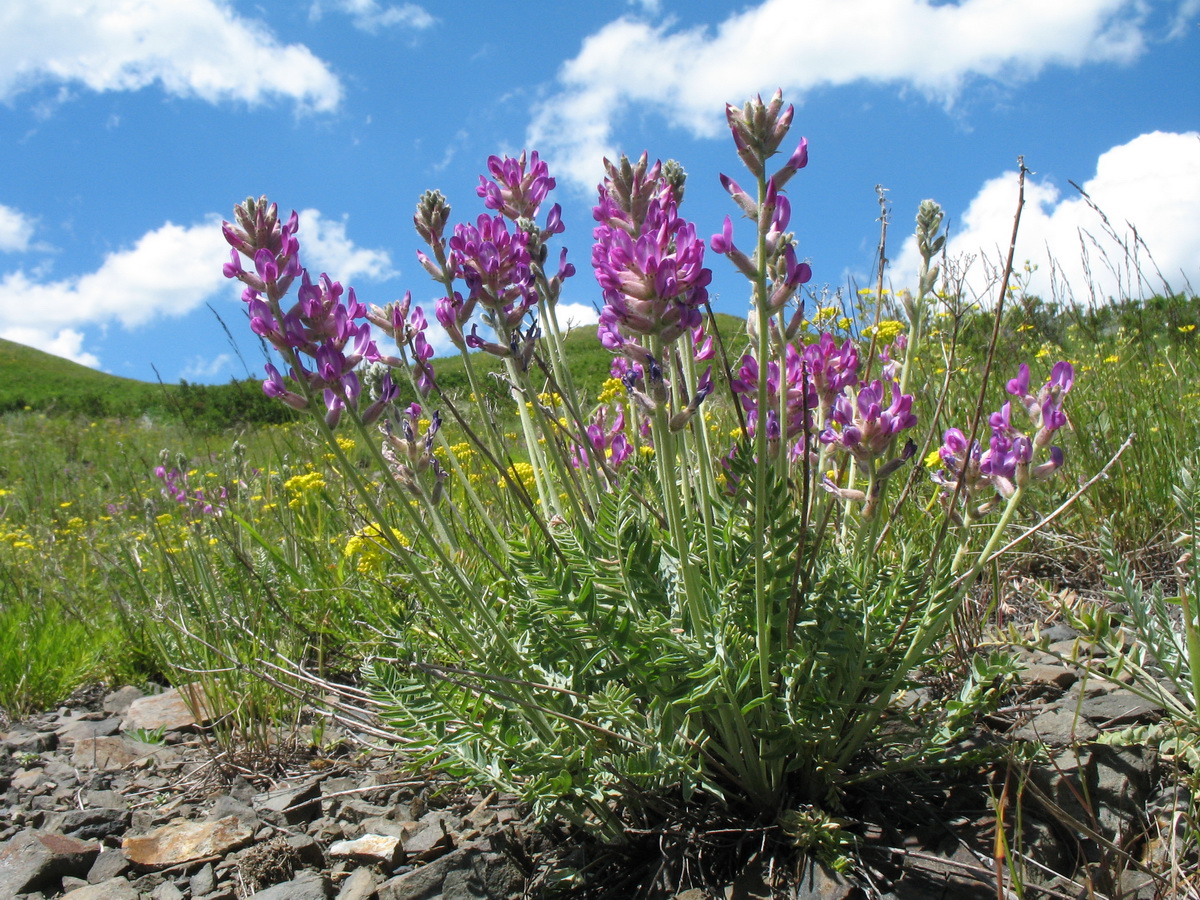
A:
[0, 0, 342, 112]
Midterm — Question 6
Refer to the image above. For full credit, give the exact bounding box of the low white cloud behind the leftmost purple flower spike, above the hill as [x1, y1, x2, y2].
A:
[0, 209, 392, 366]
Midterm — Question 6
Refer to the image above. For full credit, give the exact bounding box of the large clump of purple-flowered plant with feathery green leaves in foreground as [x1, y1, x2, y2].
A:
[218, 94, 1073, 840]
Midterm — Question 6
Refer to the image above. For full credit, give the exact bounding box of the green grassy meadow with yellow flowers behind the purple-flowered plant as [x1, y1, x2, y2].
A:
[0, 299, 1200, 720]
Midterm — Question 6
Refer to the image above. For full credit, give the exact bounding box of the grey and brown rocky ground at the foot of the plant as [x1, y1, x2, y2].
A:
[0, 626, 1198, 900]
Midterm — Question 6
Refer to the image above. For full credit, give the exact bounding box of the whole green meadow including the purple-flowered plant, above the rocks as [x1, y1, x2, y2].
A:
[7, 97, 1200, 897]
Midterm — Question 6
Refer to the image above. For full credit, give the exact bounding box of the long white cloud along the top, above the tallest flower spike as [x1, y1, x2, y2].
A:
[528, 0, 1171, 190]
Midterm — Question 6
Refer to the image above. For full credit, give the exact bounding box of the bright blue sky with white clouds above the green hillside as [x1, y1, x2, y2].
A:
[0, 0, 1200, 383]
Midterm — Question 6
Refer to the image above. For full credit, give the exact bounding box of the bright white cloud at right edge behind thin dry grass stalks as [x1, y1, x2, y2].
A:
[892, 131, 1200, 302]
